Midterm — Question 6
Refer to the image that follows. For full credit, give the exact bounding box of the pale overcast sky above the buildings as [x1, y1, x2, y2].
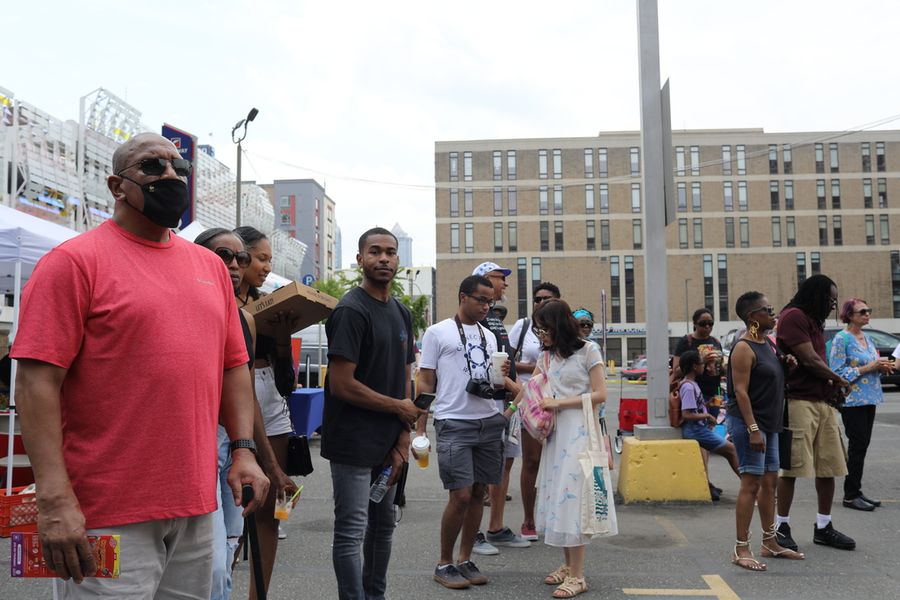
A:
[7, 0, 900, 267]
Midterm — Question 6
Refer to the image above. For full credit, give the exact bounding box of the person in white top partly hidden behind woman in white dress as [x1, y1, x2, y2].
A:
[509, 281, 560, 541]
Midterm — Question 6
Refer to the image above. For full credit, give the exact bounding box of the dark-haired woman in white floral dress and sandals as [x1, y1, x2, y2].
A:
[533, 300, 606, 598]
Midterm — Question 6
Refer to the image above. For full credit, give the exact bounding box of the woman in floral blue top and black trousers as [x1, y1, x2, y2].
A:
[828, 298, 894, 511]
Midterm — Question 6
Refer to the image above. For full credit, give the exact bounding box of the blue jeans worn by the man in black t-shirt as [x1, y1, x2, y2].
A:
[331, 462, 397, 600]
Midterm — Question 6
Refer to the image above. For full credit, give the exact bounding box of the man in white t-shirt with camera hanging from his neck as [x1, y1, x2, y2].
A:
[416, 275, 509, 589]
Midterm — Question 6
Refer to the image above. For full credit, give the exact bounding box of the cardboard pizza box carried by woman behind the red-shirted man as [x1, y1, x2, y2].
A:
[244, 281, 337, 336]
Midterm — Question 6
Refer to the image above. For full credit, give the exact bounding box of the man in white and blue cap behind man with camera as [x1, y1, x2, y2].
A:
[472, 262, 531, 554]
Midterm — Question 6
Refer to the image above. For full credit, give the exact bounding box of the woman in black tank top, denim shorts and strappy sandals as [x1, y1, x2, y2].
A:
[727, 292, 804, 571]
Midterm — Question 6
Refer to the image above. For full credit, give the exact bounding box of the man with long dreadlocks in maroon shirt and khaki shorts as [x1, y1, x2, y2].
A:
[775, 275, 856, 552]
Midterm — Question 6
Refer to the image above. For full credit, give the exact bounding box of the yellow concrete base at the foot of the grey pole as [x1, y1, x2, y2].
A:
[618, 437, 712, 504]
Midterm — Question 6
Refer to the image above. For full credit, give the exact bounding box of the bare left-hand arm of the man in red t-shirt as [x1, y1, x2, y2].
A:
[16, 359, 97, 583]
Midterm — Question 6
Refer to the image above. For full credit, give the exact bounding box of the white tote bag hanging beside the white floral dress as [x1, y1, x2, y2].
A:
[578, 394, 619, 537]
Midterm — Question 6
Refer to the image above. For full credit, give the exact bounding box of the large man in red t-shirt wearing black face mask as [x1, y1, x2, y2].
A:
[11, 134, 268, 598]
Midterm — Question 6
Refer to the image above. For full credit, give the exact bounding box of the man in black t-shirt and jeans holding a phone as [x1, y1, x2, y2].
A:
[322, 227, 422, 599]
